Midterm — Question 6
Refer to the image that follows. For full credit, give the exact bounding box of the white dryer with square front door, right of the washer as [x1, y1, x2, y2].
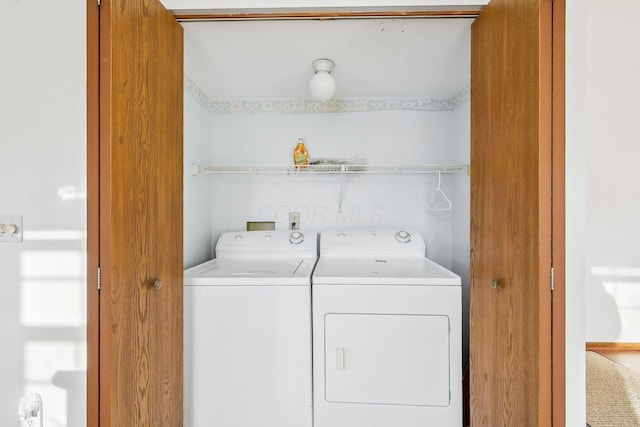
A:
[312, 230, 462, 427]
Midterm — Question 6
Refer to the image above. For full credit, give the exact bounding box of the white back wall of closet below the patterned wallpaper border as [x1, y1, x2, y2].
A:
[207, 111, 462, 267]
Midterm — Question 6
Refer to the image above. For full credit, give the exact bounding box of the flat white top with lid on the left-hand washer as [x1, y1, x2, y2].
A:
[184, 257, 316, 286]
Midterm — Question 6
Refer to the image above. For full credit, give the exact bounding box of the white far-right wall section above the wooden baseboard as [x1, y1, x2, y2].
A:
[585, 0, 640, 342]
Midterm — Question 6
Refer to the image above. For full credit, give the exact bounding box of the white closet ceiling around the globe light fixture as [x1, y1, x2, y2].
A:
[182, 18, 473, 100]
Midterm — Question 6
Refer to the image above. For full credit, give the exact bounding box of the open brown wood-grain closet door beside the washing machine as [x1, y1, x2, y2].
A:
[100, 0, 183, 427]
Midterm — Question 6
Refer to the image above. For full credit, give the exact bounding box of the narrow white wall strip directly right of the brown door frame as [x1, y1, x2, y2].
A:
[565, 0, 588, 427]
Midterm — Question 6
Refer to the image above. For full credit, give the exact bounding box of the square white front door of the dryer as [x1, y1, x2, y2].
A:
[324, 313, 450, 406]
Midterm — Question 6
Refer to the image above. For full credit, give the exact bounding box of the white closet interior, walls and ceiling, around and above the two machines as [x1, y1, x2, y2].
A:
[182, 18, 473, 426]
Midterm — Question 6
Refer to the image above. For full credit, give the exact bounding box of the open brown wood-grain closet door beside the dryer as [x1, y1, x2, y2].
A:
[470, 0, 551, 427]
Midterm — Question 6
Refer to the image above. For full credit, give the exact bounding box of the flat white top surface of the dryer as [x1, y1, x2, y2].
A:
[312, 256, 461, 286]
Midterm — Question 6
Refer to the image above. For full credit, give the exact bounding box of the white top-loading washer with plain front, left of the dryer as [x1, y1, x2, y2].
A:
[184, 231, 317, 427]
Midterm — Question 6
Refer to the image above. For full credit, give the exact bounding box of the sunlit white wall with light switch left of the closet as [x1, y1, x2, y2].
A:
[0, 0, 86, 427]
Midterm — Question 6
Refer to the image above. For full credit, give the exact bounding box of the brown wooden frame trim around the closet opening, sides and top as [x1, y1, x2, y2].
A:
[87, 0, 566, 427]
